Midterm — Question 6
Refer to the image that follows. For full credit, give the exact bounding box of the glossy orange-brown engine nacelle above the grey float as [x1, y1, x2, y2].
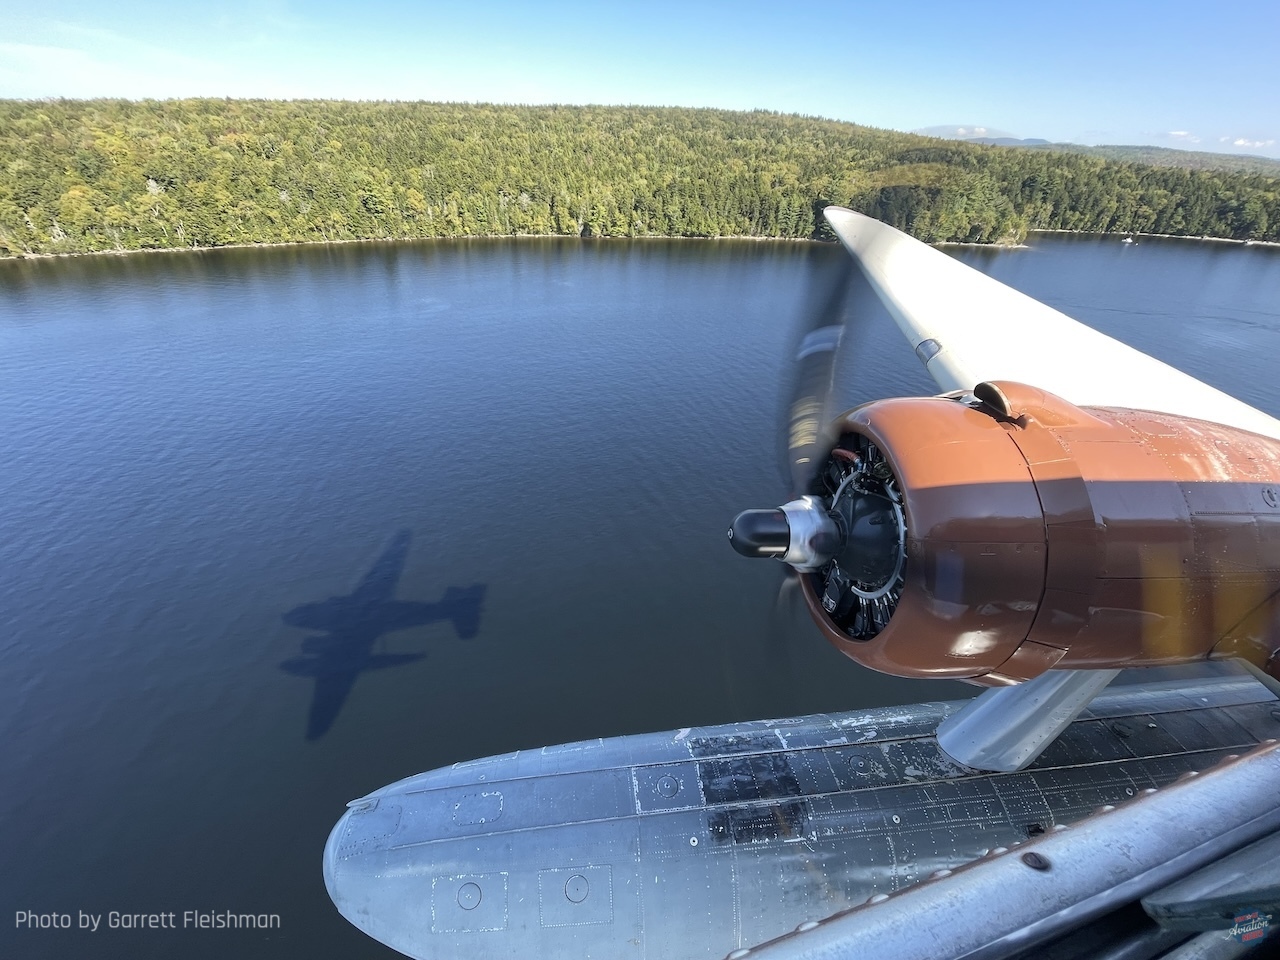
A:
[801, 383, 1280, 685]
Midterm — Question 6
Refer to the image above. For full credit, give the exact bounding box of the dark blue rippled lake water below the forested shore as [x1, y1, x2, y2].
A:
[0, 236, 1280, 959]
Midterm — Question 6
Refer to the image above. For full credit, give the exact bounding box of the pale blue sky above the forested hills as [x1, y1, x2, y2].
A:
[0, 0, 1280, 157]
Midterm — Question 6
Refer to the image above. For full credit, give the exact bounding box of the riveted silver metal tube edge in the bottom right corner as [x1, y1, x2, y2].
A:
[753, 744, 1280, 960]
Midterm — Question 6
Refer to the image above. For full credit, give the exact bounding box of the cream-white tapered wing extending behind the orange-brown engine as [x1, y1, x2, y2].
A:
[826, 207, 1280, 439]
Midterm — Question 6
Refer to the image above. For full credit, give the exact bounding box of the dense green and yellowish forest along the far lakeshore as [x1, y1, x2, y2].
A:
[0, 100, 1280, 256]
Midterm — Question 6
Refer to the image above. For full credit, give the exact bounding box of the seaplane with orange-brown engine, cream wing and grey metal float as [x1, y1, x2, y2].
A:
[323, 207, 1280, 960]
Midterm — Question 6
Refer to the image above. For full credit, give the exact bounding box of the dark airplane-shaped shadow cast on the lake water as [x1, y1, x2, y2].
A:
[280, 530, 485, 740]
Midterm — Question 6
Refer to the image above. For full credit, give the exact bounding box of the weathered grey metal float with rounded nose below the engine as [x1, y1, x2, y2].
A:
[325, 664, 1280, 960]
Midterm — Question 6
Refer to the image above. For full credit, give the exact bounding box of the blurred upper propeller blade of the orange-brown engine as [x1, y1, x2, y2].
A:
[783, 247, 854, 497]
